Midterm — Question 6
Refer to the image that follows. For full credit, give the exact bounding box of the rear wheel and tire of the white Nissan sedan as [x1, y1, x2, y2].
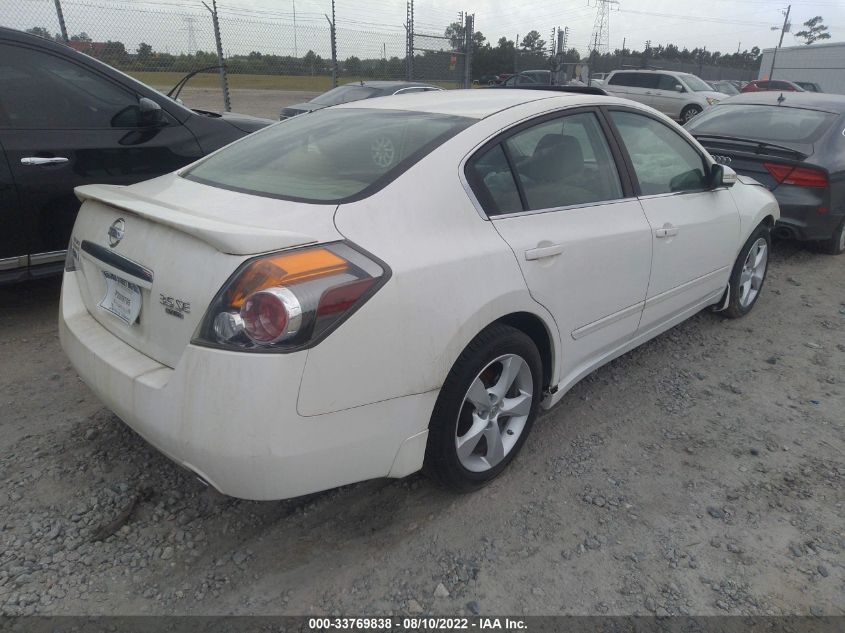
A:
[423, 324, 543, 492]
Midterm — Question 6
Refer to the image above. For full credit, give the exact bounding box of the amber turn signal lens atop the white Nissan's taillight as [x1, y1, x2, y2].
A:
[229, 248, 349, 308]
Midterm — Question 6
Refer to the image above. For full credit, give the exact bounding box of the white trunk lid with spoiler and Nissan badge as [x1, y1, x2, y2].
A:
[71, 175, 342, 367]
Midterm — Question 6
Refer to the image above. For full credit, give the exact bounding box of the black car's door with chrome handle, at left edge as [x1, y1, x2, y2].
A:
[0, 41, 202, 266]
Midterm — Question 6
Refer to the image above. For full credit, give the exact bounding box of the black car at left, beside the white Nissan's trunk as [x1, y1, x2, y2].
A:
[0, 28, 272, 283]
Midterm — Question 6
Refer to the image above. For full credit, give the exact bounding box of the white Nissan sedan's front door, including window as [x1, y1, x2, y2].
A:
[609, 108, 740, 331]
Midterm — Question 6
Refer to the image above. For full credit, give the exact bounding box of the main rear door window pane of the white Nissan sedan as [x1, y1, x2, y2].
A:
[505, 112, 622, 210]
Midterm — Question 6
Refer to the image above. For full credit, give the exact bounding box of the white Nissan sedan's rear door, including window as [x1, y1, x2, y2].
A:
[467, 109, 651, 380]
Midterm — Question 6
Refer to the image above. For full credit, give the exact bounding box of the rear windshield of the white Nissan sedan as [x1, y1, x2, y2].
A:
[182, 108, 474, 203]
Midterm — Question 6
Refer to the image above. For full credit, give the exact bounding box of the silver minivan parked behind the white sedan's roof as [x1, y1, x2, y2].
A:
[602, 70, 728, 122]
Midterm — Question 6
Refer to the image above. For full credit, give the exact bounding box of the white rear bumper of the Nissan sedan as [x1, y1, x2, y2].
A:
[59, 273, 437, 499]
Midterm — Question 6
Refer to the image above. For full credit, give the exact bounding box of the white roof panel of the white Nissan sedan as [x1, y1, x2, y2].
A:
[334, 88, 608, 119]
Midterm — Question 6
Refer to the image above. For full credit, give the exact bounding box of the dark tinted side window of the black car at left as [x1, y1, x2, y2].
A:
[0, 44, 135, 129]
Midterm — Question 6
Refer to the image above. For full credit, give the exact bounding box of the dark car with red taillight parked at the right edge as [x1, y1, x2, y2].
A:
[686, 92, 845, 255]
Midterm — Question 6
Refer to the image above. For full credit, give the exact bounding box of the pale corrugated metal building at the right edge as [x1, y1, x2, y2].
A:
[758, 42, 845, 94]
